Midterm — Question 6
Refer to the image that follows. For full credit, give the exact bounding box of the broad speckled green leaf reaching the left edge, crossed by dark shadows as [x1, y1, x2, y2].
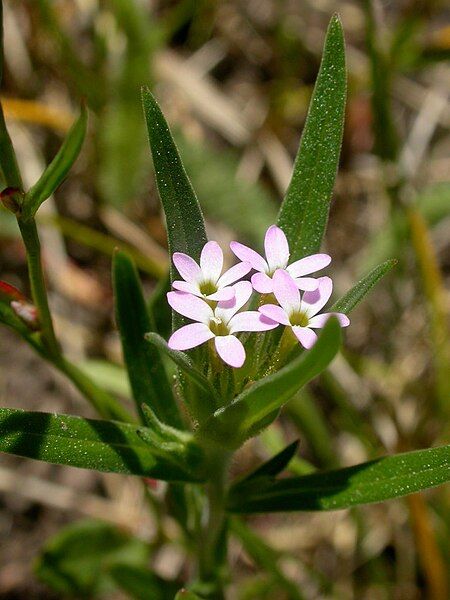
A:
[0, 408, 203, 481]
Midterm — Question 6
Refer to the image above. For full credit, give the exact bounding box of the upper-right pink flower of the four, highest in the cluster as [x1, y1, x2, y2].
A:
[230, 225, 331, 294]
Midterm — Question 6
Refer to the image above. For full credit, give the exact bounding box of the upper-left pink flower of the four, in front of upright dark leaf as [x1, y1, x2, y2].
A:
[172, 242, 252, 301]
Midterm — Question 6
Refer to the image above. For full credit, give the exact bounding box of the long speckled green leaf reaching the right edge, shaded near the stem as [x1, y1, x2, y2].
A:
[228, 445, 450, 513]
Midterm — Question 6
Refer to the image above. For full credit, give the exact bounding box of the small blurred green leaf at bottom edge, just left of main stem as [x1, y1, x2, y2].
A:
[109, 563, 178, 600]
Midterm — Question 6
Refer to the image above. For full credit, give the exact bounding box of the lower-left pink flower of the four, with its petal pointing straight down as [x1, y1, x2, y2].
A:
[167, 281, 278, 368]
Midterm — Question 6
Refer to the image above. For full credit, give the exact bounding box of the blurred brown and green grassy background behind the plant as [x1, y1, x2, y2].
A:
[0, 0, 450, 600]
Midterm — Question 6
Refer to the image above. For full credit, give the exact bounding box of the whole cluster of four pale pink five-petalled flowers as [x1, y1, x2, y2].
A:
[167, 225, 350, 368]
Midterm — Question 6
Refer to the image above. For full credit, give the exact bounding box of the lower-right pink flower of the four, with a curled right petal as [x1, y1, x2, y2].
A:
[259, 269, 350, 349]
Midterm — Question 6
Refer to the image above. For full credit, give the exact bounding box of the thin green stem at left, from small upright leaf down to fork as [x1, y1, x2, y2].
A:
[17, 217, 60, 358]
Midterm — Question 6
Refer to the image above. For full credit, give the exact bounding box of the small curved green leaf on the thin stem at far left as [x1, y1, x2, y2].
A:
[22, 105, 87, 221]
